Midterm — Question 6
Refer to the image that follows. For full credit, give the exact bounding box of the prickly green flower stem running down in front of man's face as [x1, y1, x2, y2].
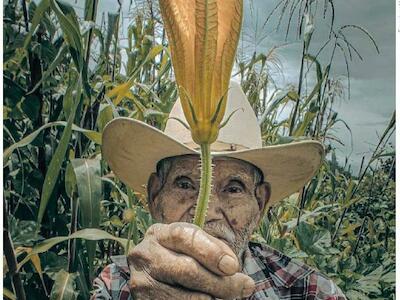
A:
[193, 144, 212, 228]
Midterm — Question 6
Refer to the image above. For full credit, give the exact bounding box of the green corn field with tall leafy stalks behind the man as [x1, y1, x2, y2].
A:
[3, 0, 395, 299]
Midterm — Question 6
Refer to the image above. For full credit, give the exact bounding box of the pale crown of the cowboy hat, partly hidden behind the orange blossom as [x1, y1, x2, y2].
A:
[164, 81, 262, 152]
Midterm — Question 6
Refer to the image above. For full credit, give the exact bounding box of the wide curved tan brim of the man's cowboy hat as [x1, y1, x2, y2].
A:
[102, 117, 324, 207]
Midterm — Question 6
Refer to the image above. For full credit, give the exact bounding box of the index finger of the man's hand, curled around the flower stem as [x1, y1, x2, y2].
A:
[148, 222, 239, 275]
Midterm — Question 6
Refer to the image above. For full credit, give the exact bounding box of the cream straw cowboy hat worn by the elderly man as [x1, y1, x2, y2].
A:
[102, 81, 324, 207]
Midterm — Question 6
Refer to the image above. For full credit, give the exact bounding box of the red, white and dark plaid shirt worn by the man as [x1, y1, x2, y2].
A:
[91, 242, 346, 300]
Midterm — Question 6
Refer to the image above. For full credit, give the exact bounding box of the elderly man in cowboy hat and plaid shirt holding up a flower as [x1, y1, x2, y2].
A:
[92, 82, 345, 300]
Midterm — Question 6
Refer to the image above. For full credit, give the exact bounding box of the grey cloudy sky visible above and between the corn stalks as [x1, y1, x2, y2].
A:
[69, 0, 395, 170]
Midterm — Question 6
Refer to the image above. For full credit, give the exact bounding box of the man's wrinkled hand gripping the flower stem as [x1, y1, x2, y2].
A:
[128, 223, 254, 300]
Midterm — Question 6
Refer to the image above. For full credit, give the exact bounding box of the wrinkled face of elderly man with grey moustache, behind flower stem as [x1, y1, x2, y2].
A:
[148, 156, 270, 258]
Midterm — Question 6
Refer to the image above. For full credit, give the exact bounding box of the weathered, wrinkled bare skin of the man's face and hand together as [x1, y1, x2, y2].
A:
[128, 156, 270, 300]
